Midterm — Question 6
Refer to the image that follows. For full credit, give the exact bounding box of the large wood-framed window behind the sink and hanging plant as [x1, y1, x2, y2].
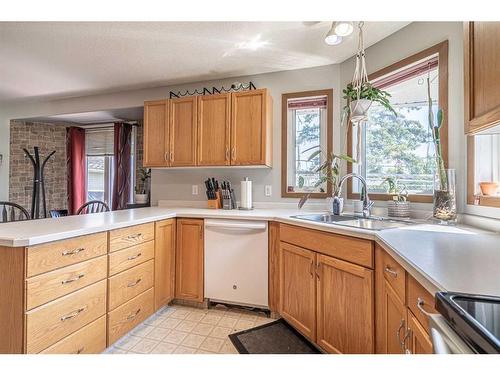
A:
[348, 42, 448, 202]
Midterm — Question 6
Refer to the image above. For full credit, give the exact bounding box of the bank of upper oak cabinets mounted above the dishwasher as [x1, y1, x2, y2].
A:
[144, 89, 272, 167]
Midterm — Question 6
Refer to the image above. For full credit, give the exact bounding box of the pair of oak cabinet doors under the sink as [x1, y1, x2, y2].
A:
[279, 236, 374, 353]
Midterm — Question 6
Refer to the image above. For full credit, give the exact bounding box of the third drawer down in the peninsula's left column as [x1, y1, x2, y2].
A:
[26, 280, 106, 353]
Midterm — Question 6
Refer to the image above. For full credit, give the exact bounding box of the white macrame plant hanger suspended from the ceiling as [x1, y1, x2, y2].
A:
[348, 21, 371, 163]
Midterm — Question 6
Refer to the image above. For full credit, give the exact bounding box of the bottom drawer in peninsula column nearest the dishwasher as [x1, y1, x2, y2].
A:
[108, 288, 154, 345]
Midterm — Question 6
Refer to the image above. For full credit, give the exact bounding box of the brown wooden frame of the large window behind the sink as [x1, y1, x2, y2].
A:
[347, 40, 448, 203]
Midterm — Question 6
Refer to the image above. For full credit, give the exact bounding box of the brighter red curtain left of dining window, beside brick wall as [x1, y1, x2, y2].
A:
[66, 127, 87, 215]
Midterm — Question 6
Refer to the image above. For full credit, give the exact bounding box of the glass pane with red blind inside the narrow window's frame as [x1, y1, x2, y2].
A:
[287, 96, 327, 192]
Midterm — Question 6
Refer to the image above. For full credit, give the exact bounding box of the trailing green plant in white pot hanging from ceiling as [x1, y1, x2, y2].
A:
[342, 82, 397, 123]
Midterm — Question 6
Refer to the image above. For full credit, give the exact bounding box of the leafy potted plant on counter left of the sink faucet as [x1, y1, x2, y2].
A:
[299, 150, 356, 213]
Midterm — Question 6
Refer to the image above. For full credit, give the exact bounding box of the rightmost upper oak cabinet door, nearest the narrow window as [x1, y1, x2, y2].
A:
[231, 89, 272, 165]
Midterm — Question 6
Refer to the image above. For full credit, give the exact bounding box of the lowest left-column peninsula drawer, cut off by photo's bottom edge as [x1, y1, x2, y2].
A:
[42, 316, 106, 354]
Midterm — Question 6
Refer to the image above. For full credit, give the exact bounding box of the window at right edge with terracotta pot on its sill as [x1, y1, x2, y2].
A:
[467, 125, 500, 207]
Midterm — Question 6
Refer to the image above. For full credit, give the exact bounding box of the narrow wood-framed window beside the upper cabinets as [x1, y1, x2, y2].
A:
[281, 90, 332, 197]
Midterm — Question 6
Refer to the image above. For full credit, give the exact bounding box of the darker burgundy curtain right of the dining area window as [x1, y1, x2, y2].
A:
[112, 123, 132, 210]
